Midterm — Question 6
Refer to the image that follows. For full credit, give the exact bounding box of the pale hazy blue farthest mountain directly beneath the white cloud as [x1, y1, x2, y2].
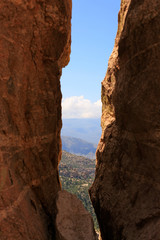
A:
[62, 118, 102, 144]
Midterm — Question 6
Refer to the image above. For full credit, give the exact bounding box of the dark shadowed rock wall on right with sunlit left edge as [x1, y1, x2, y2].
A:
[90, 0, 160, 240]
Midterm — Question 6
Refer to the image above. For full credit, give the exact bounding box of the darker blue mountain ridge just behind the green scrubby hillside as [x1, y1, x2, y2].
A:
[62, 136, 97, 159]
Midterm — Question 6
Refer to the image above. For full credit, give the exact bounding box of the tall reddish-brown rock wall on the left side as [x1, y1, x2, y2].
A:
[0, 0, 71, 240]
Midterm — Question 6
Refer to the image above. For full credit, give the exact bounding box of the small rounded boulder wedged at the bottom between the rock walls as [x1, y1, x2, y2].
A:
[56, 190, 97, 240]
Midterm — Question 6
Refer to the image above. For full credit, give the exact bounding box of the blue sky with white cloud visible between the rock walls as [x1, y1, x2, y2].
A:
[61, 0, 120, 118]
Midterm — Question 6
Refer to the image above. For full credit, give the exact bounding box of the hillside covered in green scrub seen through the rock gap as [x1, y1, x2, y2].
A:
[59, 151, 99, 230]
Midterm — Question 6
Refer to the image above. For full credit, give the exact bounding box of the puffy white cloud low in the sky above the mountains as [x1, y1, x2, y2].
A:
[62, 96, 102, 118]
